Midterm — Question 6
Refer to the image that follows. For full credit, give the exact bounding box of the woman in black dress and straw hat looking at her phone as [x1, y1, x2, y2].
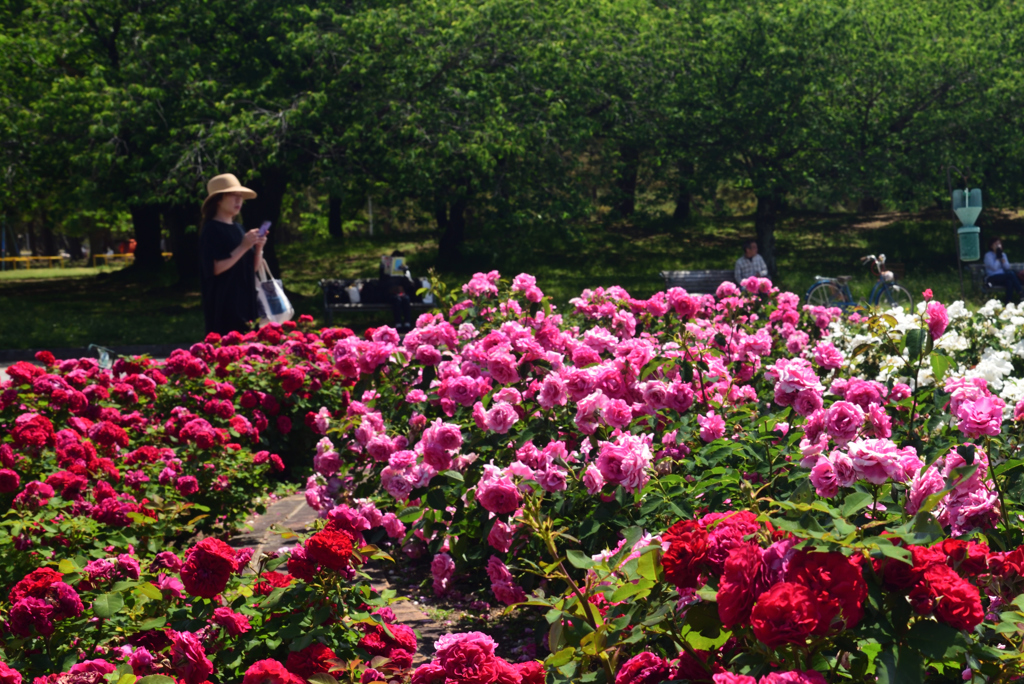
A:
[199, 173, 266, 335]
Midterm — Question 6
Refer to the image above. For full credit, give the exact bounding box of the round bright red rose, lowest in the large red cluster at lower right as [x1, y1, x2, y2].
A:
[751, 582, 818, 648]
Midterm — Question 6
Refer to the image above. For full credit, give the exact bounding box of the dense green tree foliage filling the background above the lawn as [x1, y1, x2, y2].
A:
[0, 0, 1024, 274]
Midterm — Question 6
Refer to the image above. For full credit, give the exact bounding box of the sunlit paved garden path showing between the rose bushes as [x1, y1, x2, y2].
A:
[231, 494, 447, 665]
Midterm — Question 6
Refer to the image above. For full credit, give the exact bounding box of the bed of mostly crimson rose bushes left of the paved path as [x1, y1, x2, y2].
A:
[0, 319, 432, 684]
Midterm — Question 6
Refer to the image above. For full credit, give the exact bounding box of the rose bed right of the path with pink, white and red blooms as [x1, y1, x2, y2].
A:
[306, 272, 1024, 684]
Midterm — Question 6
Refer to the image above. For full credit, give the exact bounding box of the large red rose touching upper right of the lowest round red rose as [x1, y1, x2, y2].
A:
[785, 551, 867, 634]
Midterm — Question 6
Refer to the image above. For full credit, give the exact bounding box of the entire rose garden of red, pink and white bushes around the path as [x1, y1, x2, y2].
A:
[9, 272, 1024, 684]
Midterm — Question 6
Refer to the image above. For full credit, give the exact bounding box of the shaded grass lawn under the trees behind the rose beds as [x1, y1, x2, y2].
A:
[0, 206, 1024, 349]
